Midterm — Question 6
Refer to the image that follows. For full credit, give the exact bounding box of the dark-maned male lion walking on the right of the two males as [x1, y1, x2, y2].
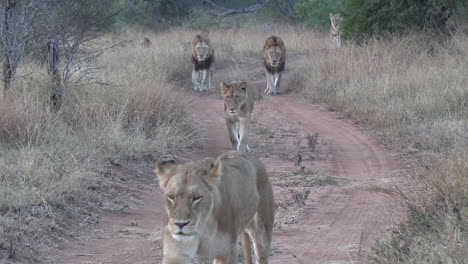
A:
[263, 36, 286, 94]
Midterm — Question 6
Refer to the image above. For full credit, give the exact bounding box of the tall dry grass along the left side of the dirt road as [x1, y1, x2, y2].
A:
[0, 30, 198, 263]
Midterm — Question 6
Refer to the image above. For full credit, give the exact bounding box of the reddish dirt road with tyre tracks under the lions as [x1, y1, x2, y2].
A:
[47, 81, 399, 264]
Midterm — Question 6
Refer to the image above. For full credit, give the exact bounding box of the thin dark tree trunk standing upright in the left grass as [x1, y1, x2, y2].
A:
[47, 38, 63, 111]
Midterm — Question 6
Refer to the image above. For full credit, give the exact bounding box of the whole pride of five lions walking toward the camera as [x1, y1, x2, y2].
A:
[155, 18, 341, 264]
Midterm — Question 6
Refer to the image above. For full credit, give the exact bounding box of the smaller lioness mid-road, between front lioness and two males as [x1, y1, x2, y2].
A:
[220, 82, 254, 151]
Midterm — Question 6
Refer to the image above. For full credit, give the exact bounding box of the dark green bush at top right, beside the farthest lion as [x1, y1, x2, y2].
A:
[341, 0, 466, 40]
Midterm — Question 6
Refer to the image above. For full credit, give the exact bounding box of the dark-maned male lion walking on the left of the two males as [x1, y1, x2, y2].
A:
[192, 35, 214, 91]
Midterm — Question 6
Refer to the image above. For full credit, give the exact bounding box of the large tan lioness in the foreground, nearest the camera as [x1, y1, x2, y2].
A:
[156, 152, 274, 264]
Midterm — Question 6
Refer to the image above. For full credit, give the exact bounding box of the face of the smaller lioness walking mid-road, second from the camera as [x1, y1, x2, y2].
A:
[220, 82, 247, 116]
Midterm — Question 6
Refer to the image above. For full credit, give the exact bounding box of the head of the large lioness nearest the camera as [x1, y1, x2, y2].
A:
[156, 157, 219, 240]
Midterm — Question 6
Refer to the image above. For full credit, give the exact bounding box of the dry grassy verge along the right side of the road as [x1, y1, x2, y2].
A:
[289, 33, 468, 263]
